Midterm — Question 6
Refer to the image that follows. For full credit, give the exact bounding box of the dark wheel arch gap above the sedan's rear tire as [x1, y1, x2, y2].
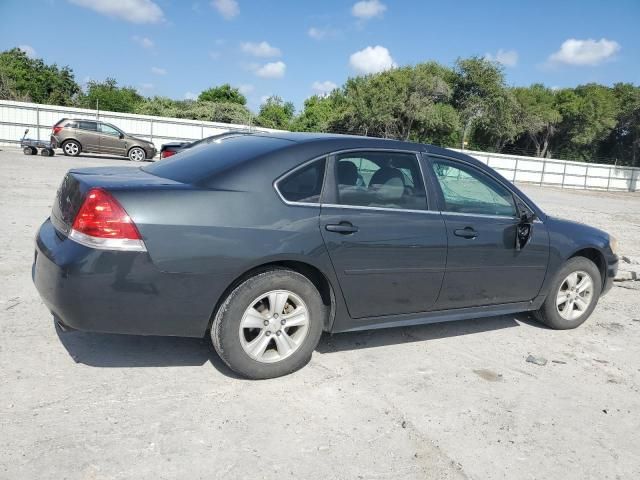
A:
[208, 260, 336, 331]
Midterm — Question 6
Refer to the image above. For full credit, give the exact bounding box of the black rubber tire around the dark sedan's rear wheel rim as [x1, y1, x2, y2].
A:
[211, 269, 329, 379]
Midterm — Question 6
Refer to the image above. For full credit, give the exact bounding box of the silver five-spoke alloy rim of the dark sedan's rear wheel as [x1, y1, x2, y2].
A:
[239, 290, 309, 363]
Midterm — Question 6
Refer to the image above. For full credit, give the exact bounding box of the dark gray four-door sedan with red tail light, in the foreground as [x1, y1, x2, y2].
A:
[33, 133, 618, 378]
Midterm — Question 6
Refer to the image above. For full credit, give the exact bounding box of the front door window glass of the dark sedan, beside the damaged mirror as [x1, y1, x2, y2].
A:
[433, 160, 516, 217]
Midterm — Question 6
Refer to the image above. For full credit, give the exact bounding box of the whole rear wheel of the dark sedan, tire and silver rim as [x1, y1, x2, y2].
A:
[211, 269, 328, 379]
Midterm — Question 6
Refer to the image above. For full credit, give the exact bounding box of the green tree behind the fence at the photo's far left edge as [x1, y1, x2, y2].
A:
[0, 48, 80, 105]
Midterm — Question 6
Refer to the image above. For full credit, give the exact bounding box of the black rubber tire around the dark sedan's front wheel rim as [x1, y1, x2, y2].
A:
[534, 257, 602, 330]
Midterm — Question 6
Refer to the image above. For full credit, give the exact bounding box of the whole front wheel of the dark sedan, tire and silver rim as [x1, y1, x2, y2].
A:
[535, 257, 602, 330]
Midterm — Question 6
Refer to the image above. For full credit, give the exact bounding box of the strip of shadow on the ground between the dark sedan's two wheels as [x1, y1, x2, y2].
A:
[316, 312, 546, 354]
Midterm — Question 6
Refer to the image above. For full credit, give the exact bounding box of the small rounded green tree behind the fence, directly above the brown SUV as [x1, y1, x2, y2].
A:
[78, 78, 144, 113]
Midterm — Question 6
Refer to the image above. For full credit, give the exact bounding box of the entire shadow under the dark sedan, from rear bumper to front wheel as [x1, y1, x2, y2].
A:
[54, 313, 546, 379]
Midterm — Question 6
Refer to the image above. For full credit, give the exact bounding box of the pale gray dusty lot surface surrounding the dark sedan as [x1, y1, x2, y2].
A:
[0, 149, 640, 480]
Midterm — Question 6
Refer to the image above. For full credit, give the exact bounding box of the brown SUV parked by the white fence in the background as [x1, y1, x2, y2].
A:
[51, 118, 156, 162]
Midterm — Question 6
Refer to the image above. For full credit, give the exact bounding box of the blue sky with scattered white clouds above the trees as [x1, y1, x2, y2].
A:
[0, 0, 640, 109]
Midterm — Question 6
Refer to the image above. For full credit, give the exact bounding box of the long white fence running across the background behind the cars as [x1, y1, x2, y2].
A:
[0, 100, 640, 192]
